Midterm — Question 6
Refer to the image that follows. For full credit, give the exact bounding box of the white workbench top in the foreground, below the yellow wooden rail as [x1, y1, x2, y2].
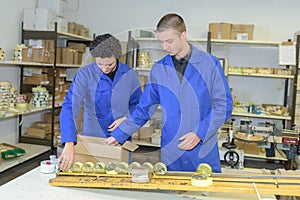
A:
[0, 167, 275, 200]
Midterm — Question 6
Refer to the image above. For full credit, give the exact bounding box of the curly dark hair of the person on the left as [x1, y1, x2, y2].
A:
[89, 33, 122, 59]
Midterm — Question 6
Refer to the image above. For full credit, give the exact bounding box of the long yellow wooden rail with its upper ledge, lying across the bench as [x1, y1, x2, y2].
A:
[49, 172, 300, 196]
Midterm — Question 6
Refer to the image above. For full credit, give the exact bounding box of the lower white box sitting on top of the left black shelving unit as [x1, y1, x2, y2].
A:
[23, 8, 56, 30]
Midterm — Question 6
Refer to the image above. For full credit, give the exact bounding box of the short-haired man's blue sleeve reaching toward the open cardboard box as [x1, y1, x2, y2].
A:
[111, 70, 159, 144]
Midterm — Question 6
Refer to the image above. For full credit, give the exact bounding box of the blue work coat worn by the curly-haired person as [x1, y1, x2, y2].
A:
[60, 62, 142, 145]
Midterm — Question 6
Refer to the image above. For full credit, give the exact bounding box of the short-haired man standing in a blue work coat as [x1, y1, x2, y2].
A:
[105, 14, 232, 172]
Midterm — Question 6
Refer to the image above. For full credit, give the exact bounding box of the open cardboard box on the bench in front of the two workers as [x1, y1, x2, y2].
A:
[75, 135, 138, 163]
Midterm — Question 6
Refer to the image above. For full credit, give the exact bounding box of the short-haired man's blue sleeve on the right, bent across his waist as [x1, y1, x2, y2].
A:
[196, 57, 232, 143]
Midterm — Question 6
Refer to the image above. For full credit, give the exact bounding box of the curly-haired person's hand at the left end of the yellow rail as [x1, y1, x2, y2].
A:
[57, 142, 75, 171]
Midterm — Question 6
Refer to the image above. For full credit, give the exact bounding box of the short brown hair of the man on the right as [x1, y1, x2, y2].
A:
[156, 13, 186, 33]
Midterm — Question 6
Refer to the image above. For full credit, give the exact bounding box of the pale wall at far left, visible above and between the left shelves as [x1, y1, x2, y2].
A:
[0, 0, 37, 144]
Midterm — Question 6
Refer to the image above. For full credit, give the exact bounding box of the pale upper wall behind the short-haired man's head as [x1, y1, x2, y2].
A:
[78, 0, 300, 41]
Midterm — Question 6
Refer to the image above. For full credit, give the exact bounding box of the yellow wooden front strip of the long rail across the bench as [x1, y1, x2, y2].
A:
[49, 176, 300, 196]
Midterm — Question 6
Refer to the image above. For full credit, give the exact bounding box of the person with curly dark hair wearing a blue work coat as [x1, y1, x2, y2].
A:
[58, 34, 142, 170]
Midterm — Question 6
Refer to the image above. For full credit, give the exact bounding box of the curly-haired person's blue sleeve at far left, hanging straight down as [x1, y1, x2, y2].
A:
[60, 71, 87, 146]
